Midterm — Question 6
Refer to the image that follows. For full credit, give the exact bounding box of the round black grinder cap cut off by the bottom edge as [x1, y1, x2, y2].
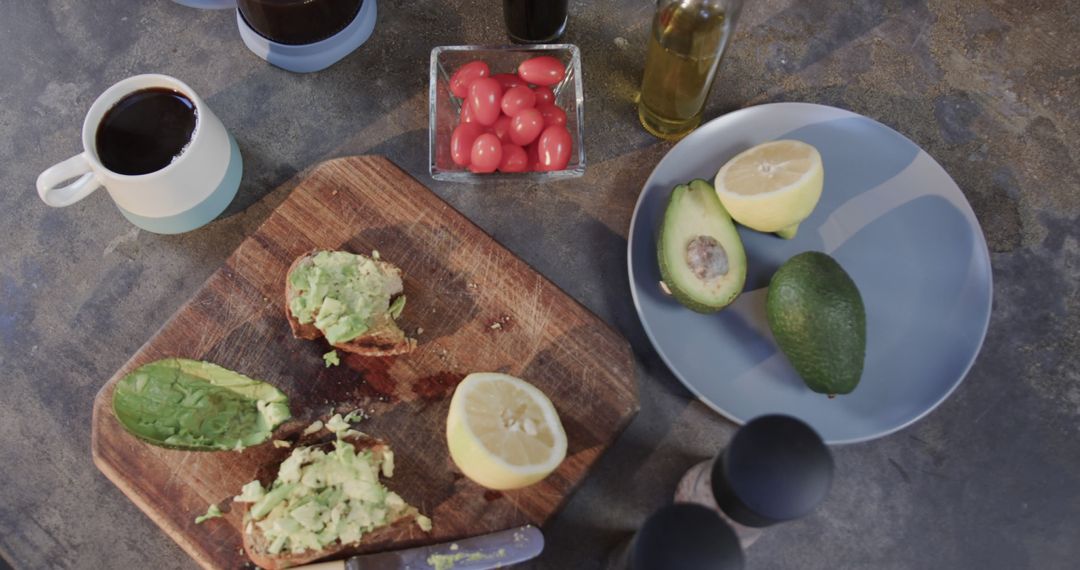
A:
[630, 503, 743, 570]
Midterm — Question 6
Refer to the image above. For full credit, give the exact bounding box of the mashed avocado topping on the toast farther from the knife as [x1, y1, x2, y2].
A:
[288, 252, 405, 344]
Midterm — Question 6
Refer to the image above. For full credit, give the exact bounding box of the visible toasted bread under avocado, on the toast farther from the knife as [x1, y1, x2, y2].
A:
[285, 249, 416, 356]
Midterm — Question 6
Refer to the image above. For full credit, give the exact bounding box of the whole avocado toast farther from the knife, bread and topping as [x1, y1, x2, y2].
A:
[285, 249, 416, 356]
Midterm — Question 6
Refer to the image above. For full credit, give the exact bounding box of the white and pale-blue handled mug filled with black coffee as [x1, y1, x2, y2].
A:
[37, 74, 244, 233]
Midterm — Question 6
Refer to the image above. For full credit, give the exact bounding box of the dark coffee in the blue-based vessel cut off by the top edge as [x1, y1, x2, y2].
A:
[237, 0, 364, 45]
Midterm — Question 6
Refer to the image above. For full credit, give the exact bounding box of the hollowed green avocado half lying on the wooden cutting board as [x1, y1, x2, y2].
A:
[112, 358, 289, 451]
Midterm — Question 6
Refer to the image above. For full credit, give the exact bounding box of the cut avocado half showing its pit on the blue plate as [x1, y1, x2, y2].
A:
[657, 180, 746, 313]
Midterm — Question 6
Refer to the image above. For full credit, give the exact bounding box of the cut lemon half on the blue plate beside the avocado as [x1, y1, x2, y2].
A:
[714, 140, 825, 239]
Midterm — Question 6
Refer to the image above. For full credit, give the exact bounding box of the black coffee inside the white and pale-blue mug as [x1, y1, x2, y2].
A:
[95, 87, 198, 175]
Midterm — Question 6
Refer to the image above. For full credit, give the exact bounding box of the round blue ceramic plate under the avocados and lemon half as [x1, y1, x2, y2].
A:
[627, 103, 991, 444]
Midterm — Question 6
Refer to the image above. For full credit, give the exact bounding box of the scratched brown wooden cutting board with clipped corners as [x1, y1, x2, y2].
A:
[92, 157, 638, 568]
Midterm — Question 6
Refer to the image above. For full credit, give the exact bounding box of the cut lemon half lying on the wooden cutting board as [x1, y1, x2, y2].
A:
[446, 372, 566, 490]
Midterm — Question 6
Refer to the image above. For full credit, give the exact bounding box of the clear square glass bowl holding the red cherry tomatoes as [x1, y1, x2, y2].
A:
[428, 43, 585, 182]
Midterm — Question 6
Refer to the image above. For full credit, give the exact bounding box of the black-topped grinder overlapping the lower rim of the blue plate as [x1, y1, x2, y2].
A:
[675, 416, 833, 548]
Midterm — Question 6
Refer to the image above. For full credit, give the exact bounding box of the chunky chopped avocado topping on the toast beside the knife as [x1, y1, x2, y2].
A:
[233, 438, 431, 554]
